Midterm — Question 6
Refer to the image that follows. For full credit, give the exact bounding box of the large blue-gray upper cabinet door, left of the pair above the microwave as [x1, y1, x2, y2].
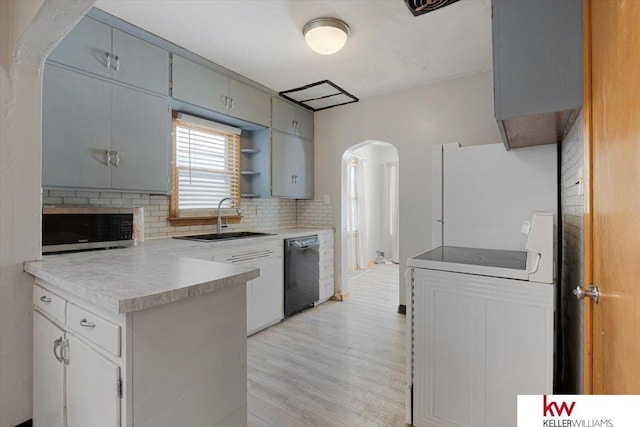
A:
[42, 65, 111, 188]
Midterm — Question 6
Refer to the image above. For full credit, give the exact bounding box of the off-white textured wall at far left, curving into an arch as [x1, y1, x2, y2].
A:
[0, 0, 93, 427]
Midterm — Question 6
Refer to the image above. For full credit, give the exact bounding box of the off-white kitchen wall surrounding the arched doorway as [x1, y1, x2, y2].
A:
[314, 72, 500, 304]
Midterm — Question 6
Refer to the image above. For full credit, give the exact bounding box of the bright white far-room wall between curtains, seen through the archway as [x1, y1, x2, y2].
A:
[350, 142, 398, 262]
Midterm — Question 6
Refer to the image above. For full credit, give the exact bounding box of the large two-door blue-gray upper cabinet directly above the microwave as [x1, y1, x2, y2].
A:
[42, 64, 170, 193]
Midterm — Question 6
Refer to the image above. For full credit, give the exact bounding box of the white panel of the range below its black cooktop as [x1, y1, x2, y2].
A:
[407, 268, 554, 427]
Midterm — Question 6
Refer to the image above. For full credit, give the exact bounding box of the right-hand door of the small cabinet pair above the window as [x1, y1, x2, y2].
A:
[229, 80, 271, 127]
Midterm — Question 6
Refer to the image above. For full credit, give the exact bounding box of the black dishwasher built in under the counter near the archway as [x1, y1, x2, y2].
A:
[284, 236, 320, 317]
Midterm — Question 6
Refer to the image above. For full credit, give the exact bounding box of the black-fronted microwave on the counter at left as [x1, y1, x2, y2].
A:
[42, 207, 133, 254]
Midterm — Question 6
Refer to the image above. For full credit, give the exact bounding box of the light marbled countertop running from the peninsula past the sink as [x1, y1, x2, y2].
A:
[24, 227, 331, 313]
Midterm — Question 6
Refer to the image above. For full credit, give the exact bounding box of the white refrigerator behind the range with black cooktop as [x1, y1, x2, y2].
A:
[431, 143, 558, 250]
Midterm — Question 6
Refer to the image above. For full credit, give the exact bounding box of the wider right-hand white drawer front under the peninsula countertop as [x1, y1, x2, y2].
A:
[67, 304, 120, 356]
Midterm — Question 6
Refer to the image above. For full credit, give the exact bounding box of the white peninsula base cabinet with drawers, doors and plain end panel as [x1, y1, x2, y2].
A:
[33, 279, 247, 427]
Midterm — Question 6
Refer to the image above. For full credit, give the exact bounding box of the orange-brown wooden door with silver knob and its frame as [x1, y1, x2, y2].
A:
[583, 0, 640, 394]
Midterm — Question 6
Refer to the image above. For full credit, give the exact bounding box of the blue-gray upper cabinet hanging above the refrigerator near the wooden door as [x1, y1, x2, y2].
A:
[492, 0, 582, 148]
